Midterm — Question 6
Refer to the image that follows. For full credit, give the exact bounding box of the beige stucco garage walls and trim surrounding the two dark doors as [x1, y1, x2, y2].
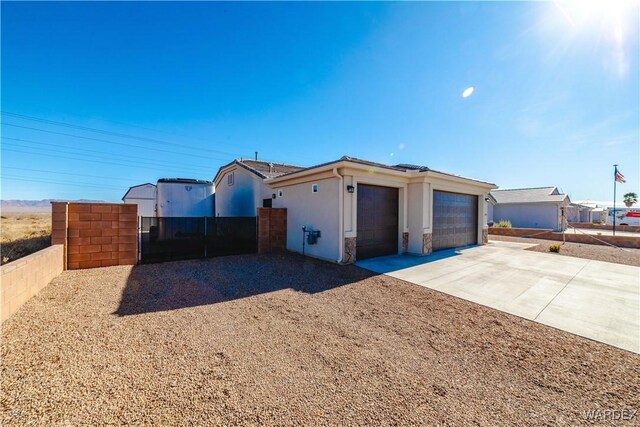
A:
[270, 167, 490, 261]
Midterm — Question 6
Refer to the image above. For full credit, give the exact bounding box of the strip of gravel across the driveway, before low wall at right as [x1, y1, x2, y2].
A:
[489, 234, 640, 267]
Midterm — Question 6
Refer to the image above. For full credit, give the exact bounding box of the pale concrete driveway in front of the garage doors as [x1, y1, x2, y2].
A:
[356, 241, 640, 353]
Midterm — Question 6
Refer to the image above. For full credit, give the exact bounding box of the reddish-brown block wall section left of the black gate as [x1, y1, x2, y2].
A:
[51, 202, 138, 270]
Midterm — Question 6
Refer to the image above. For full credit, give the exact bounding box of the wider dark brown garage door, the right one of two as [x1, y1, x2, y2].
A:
[432, 191, 478, 251]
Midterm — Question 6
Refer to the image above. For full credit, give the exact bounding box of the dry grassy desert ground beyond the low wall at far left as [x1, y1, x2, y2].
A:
[0, 216, 51, 264]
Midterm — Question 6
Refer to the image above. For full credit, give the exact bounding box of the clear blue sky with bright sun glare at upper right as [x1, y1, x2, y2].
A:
[1, 1, 640, 201]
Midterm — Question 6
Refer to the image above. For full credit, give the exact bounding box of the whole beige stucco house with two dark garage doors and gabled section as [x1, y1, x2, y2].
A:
[215, 156, 496, 263]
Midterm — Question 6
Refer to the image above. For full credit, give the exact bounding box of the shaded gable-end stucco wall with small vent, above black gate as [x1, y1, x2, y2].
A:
[215, 166, 273, 216]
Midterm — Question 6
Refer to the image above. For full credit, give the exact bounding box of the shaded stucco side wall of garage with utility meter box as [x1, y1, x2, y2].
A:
[273, 178, 342, 262]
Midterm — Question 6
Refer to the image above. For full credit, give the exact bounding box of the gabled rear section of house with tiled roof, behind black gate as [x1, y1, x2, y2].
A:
[213, 160, 303, 216]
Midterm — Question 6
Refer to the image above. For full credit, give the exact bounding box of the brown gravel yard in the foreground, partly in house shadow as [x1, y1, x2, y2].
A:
[0, 254, 640, 426]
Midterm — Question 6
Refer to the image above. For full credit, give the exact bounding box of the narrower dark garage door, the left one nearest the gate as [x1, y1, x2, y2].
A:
[356, 184, 398, 259]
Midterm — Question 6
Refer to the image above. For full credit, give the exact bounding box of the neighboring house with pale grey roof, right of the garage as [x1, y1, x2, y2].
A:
[491, 187, 571, 230]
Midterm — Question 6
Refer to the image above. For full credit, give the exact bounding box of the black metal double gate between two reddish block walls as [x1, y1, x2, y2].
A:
[139, 217, 258, 264]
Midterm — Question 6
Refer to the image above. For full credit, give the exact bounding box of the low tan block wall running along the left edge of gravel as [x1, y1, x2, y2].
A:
[0, 244, 64, 322]
